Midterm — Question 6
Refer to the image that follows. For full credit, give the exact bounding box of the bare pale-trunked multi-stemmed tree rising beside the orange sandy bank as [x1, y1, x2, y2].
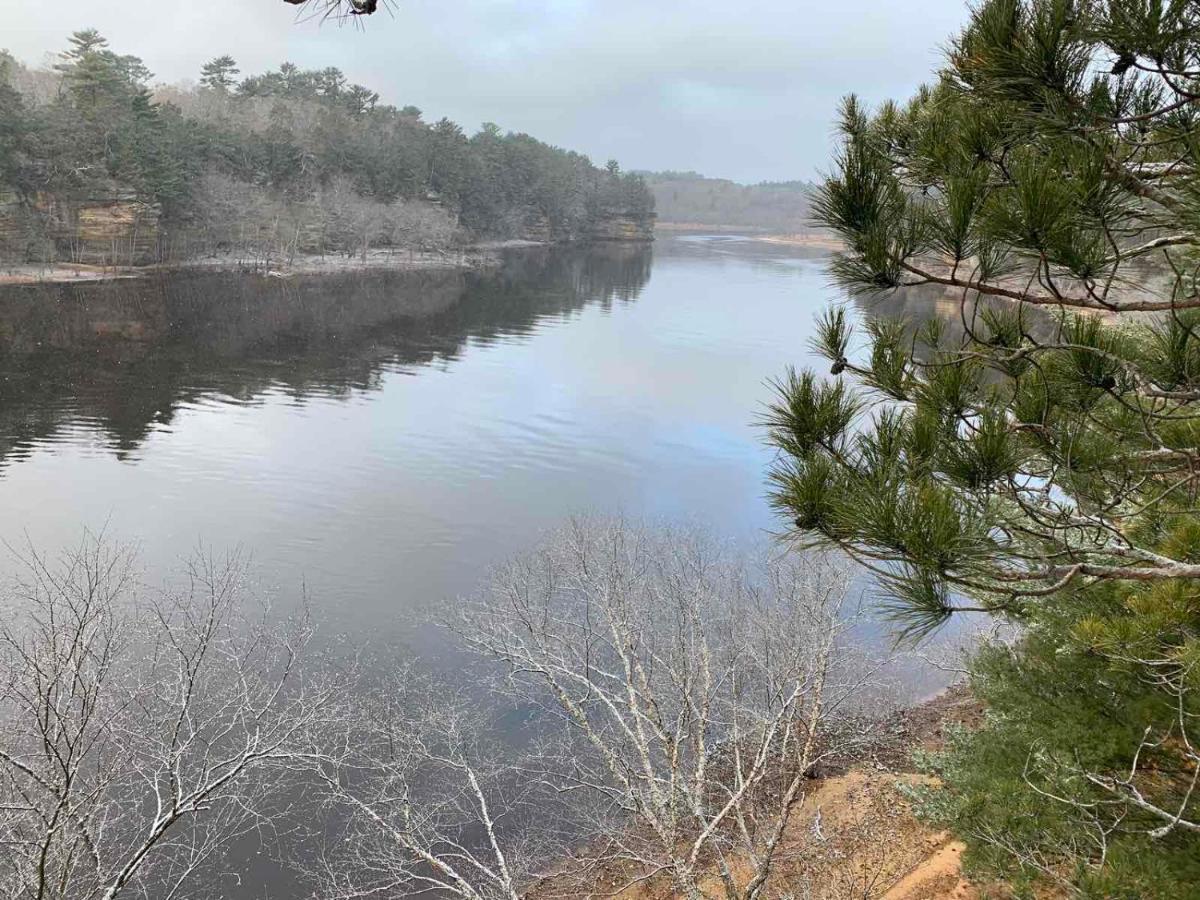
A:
[441, 521, 892, 900]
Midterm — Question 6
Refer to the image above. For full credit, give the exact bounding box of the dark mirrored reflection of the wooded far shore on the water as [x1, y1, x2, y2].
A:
[0, 245, 652, 472]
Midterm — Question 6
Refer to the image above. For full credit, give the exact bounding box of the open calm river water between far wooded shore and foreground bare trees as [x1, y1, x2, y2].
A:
[0, 238, 835, 635]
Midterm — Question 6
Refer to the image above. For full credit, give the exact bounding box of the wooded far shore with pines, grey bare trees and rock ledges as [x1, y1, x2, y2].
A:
[0, 30, 654, 271]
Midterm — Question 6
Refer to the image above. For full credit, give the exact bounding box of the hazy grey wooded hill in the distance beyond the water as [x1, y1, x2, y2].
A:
[640, 172, 817, 234]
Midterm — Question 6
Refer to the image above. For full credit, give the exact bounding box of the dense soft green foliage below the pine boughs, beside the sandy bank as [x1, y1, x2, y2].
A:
[918, 578, 1200, 900]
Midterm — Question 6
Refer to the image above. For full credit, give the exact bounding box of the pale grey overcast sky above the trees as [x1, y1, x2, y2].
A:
[0, 0, 966, 182]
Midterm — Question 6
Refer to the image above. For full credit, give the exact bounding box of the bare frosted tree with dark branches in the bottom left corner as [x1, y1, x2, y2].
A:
[0, 536, 336, 900]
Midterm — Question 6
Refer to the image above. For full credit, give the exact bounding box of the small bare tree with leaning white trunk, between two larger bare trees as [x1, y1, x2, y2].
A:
[304, 670, 562, 900]
